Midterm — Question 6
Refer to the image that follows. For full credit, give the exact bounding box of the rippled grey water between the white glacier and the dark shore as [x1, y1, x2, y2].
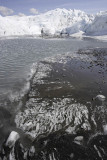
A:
[0, 39, 106, 95]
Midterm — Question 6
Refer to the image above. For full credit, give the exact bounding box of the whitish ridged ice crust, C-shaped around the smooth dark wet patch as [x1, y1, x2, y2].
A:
[15, 54, 91, 138]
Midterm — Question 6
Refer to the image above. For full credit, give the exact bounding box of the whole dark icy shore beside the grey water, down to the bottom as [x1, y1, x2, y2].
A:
[0, 48, 107, 160]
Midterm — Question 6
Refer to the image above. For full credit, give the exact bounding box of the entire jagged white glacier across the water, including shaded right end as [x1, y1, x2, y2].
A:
[0, 8, 107, 36]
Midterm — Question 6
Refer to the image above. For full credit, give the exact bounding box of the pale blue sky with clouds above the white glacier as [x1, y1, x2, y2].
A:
[0, 0, 107, 16]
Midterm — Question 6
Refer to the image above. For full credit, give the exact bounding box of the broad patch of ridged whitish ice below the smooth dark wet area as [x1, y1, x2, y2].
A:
[15, 98, 90, 138]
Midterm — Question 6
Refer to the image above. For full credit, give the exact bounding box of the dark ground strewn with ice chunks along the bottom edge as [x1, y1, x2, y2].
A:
[0, 133, 107, 160]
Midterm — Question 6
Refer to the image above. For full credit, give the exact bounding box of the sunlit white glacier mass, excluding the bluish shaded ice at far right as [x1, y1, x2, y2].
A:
[0, 9, 93, 36]
